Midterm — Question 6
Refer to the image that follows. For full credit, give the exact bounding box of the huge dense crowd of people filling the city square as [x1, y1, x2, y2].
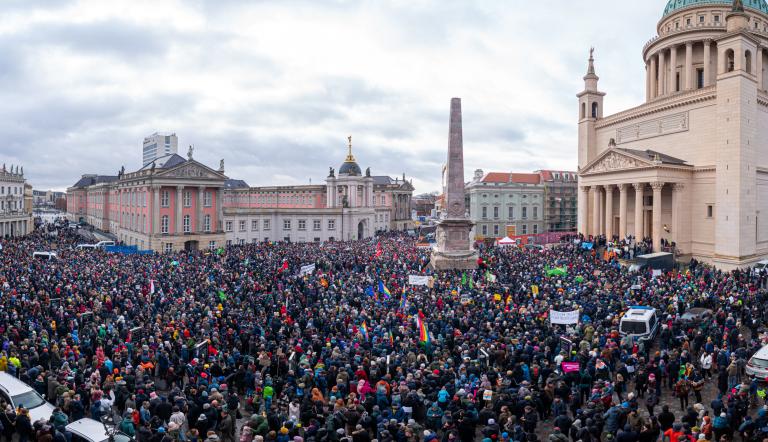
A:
[0, 224, 768, 442]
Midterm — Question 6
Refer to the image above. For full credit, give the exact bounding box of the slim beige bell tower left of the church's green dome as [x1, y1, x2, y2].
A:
[576, 48, 605, 169]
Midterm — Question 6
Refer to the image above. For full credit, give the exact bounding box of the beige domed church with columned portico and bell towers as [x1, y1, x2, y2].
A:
[578, 0, 768, 268]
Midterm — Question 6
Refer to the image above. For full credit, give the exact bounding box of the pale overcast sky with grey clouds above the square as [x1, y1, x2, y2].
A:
[0, 0, 666, 192]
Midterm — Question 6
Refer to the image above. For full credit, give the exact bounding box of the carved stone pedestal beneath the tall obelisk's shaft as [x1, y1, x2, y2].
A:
[429, 219, 478, 270]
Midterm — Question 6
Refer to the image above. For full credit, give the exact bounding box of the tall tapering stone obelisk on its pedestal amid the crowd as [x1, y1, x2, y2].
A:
[431, 98, 477, 270]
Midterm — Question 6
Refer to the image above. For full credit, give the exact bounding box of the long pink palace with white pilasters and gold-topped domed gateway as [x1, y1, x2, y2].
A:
[67, 139, 413, 252]
